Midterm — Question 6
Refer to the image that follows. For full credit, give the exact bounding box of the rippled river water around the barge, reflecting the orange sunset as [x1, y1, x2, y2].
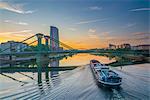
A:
[0, 54, 150, 100]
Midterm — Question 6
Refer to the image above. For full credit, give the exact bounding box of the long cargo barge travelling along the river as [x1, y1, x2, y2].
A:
[90, 60, 122, 86]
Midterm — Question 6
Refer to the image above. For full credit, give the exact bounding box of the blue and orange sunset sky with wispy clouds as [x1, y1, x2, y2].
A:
[0, 0, 150, 49]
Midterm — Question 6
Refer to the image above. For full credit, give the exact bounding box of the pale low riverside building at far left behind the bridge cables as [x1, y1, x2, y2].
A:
[0, 41, 29, 53]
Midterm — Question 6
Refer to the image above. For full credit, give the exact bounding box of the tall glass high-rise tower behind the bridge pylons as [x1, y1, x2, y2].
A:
[50, 26, 59, 50]
